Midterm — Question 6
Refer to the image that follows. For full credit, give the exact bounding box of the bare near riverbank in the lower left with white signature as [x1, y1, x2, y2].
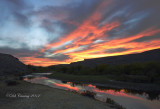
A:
[0, 76, 114, 109]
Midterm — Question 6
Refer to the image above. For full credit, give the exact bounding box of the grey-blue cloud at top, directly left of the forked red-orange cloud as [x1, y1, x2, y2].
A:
[31, 0, 102, 34]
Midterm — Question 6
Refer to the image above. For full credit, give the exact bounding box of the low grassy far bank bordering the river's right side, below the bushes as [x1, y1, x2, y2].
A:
[49, 72, 160, 93]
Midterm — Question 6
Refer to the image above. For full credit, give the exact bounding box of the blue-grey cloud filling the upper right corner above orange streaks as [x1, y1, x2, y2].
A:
[105, 0, 160, 39]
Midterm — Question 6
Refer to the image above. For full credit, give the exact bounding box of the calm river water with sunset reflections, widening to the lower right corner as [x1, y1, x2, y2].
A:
[24, 75, 160, 109]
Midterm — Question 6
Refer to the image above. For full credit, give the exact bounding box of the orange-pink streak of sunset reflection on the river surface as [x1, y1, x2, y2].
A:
[24, 77, 143, 100]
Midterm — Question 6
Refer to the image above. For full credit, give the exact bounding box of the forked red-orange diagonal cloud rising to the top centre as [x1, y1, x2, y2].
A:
[41, 1, 114, 52]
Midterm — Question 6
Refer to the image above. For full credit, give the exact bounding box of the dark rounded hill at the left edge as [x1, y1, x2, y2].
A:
[0, 53, 27, 75]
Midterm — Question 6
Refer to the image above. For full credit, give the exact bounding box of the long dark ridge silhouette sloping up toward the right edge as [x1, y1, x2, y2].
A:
[67, 49, 160, 67]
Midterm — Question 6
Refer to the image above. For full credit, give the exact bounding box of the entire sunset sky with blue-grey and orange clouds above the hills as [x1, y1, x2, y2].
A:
[0, 0, 160, 66]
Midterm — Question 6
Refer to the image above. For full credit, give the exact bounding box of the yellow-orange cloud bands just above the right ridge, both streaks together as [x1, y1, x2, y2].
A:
[63, 29, 160, 61]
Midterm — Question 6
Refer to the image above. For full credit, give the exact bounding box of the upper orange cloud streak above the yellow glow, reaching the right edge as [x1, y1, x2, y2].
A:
[72, 29, 160, 53]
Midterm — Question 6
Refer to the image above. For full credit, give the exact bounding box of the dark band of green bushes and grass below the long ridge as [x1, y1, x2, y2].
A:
[53, 62, 160, 84]
